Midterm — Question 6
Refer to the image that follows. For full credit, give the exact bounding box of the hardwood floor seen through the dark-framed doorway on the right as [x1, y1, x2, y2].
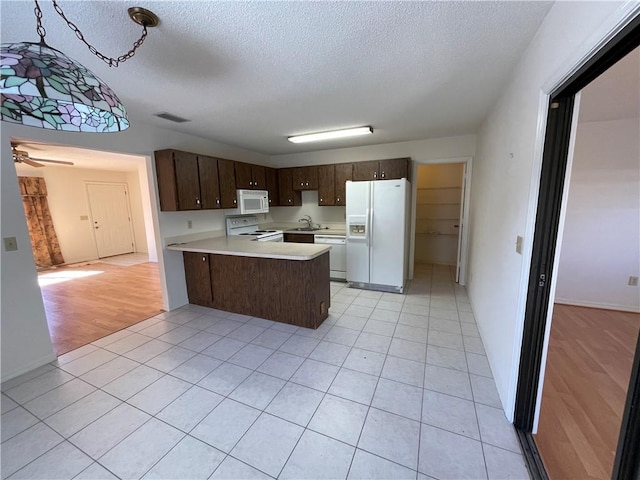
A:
[534, 304, 640, 480]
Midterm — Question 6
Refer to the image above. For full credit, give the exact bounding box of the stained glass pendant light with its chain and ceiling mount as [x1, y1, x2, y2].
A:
[0, 0, 158, 133]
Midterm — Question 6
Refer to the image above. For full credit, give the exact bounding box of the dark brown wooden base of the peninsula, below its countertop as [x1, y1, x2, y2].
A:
[184, 252, 331, 328]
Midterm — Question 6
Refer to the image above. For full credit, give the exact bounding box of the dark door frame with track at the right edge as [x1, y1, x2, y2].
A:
[514, 15, 640, 480]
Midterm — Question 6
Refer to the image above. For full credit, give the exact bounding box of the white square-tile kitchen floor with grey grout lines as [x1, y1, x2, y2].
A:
[1, 266, 529, 480]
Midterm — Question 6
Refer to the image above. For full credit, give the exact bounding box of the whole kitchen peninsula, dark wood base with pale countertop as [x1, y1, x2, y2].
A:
[167, 237, 331, 328]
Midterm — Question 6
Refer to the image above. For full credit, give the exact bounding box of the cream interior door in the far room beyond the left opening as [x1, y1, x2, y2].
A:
[87, 183, 134, 258]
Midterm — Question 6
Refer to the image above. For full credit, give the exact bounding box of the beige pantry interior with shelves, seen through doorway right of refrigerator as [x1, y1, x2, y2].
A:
[415, 163, 464, 265]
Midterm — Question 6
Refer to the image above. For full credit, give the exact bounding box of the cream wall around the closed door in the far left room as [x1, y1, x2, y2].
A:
[16, 166, 147, 263]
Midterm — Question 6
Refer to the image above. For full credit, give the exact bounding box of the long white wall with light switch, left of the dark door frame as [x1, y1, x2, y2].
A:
[468, 2, 635, 419]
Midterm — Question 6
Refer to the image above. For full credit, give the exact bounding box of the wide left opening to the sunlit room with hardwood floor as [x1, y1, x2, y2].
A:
[16, 139, 163, 356]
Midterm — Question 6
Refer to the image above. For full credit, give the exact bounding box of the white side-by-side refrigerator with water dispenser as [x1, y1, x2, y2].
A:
[346, 178, 411, 293]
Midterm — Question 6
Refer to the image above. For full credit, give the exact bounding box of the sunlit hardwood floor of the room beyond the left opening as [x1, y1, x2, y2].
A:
[38, 262, 162, 355]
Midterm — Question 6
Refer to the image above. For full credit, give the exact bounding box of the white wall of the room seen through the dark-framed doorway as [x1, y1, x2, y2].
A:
[556, 118, 640, 311]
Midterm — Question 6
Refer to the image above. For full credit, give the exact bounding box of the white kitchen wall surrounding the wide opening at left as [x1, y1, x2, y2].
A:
[0, 119, 268, 381]
